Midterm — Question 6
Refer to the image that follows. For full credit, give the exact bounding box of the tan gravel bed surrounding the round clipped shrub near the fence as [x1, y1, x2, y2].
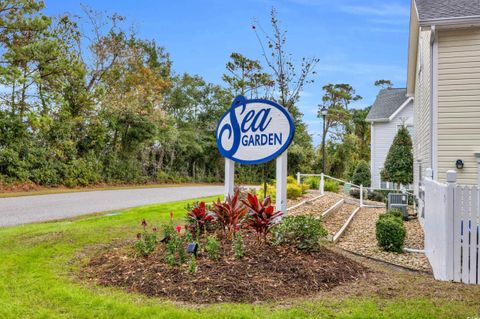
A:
[337, 208, 431, 271]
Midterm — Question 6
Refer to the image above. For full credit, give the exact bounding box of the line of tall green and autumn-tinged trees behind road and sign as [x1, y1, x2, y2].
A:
[0, 0, 369, 186]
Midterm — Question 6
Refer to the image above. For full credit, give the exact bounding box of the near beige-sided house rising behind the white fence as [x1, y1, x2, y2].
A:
[407, 0, 480, 195]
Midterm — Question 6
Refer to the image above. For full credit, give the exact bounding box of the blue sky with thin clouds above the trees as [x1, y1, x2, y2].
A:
[45, 0, 410, 145]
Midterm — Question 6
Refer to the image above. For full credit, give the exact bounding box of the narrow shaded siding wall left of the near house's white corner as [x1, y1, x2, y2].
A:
[413, 31, 432, 192]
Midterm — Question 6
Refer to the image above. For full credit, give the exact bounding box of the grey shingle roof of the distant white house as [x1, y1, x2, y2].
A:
[367, 89, 408, 121]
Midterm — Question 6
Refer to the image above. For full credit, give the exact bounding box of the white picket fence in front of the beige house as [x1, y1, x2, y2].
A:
[422, 169, 480, 284]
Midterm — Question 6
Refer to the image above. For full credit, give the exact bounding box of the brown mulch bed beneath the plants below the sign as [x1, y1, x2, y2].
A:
[83, 232, 371, 303]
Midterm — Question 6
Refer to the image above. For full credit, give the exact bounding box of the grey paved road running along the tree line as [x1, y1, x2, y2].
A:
[0, 186, 223, 226]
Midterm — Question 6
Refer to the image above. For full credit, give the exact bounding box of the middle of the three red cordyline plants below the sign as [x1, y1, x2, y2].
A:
[212, 190, 248, 239]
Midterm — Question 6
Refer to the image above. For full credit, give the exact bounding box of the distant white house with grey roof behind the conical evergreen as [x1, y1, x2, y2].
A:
[366, 88, 413, 188]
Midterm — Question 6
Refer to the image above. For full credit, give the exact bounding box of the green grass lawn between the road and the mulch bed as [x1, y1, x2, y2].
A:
[0, 198, 478, 319]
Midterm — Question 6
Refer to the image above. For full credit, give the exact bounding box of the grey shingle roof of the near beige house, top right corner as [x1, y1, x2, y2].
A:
[415, 0, 480, 21]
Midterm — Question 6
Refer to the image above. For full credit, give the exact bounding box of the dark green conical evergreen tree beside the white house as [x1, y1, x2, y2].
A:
[380, 127, 413, 188]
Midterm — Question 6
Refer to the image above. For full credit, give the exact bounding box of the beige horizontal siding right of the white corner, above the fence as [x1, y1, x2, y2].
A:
[438, 28, 480, 184]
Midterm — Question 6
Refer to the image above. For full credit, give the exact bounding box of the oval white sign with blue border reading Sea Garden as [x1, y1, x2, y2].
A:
[216, 96, 295, 164]
